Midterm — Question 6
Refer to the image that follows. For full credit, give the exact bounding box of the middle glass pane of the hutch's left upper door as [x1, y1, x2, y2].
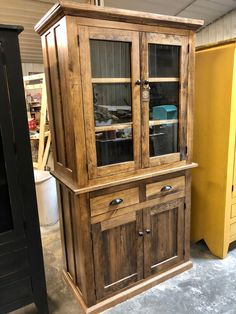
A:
[93, 83, 132, 126]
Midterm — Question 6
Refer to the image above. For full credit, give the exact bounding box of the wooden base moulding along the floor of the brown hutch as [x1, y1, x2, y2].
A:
[63, 261, 193, 314]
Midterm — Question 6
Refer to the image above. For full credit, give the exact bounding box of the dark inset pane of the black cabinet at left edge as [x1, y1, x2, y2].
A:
[0, 133, 13, 233]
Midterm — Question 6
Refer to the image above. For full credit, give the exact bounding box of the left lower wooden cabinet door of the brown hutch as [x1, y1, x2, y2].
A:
[92, 210, 143, 300]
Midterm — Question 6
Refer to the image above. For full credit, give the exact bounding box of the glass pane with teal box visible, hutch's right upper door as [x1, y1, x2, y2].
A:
[149, 82, 179, 120]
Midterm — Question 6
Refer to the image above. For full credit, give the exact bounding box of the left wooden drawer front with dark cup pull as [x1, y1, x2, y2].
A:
[90, 187, 139, 217]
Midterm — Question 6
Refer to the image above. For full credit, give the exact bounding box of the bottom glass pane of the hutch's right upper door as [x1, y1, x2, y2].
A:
[149, 123, 178, 157]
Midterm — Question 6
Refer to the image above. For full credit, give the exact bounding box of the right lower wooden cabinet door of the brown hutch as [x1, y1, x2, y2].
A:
[143, 198, 184, 277]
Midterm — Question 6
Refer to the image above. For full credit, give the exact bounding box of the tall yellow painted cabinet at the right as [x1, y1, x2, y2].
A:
[191, 40, 236, 258]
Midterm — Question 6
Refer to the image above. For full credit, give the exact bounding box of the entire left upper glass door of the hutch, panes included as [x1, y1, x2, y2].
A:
[80, 27, 140, 178]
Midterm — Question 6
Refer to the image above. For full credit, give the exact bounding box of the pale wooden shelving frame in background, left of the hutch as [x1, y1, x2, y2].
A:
[24, 73, 51, 170]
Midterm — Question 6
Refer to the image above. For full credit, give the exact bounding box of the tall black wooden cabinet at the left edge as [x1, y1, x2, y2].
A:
[0, 25, 48, 314]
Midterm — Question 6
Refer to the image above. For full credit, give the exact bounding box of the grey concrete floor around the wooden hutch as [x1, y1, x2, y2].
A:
[12, 225, 236, 314]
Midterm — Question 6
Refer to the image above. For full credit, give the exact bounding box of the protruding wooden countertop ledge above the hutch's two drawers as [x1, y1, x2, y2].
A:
[51, 162, 198, 194]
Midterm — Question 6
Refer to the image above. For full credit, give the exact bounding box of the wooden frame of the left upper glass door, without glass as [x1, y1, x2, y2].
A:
[78, 26, 141, 179]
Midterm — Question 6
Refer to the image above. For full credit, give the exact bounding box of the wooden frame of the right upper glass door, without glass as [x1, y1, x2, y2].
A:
[140, 33, 189, 168]
